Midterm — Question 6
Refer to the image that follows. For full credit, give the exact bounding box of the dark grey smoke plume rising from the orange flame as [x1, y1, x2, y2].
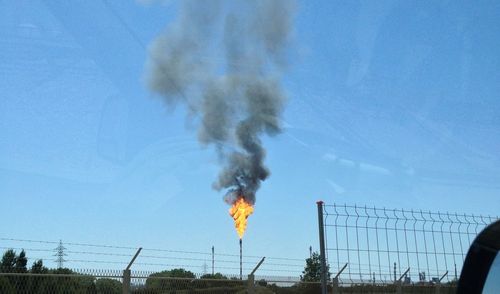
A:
[147, 0, 294, 204]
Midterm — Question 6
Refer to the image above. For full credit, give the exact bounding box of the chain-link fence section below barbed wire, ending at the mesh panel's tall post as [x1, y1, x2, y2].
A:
[0, 269, 320, 294]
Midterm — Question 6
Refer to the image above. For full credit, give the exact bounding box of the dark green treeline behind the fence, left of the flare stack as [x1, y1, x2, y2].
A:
[0, 249, 245, 294]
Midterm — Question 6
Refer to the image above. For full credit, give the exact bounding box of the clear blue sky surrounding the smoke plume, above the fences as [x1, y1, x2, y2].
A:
[0, 0, 500, 276]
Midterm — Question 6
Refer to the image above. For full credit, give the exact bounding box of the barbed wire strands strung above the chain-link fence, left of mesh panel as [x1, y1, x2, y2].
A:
[0, 235, 307, 277]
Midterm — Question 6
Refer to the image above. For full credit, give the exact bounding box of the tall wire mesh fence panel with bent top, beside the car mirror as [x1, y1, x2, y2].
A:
[323, 204, 498, 284]
